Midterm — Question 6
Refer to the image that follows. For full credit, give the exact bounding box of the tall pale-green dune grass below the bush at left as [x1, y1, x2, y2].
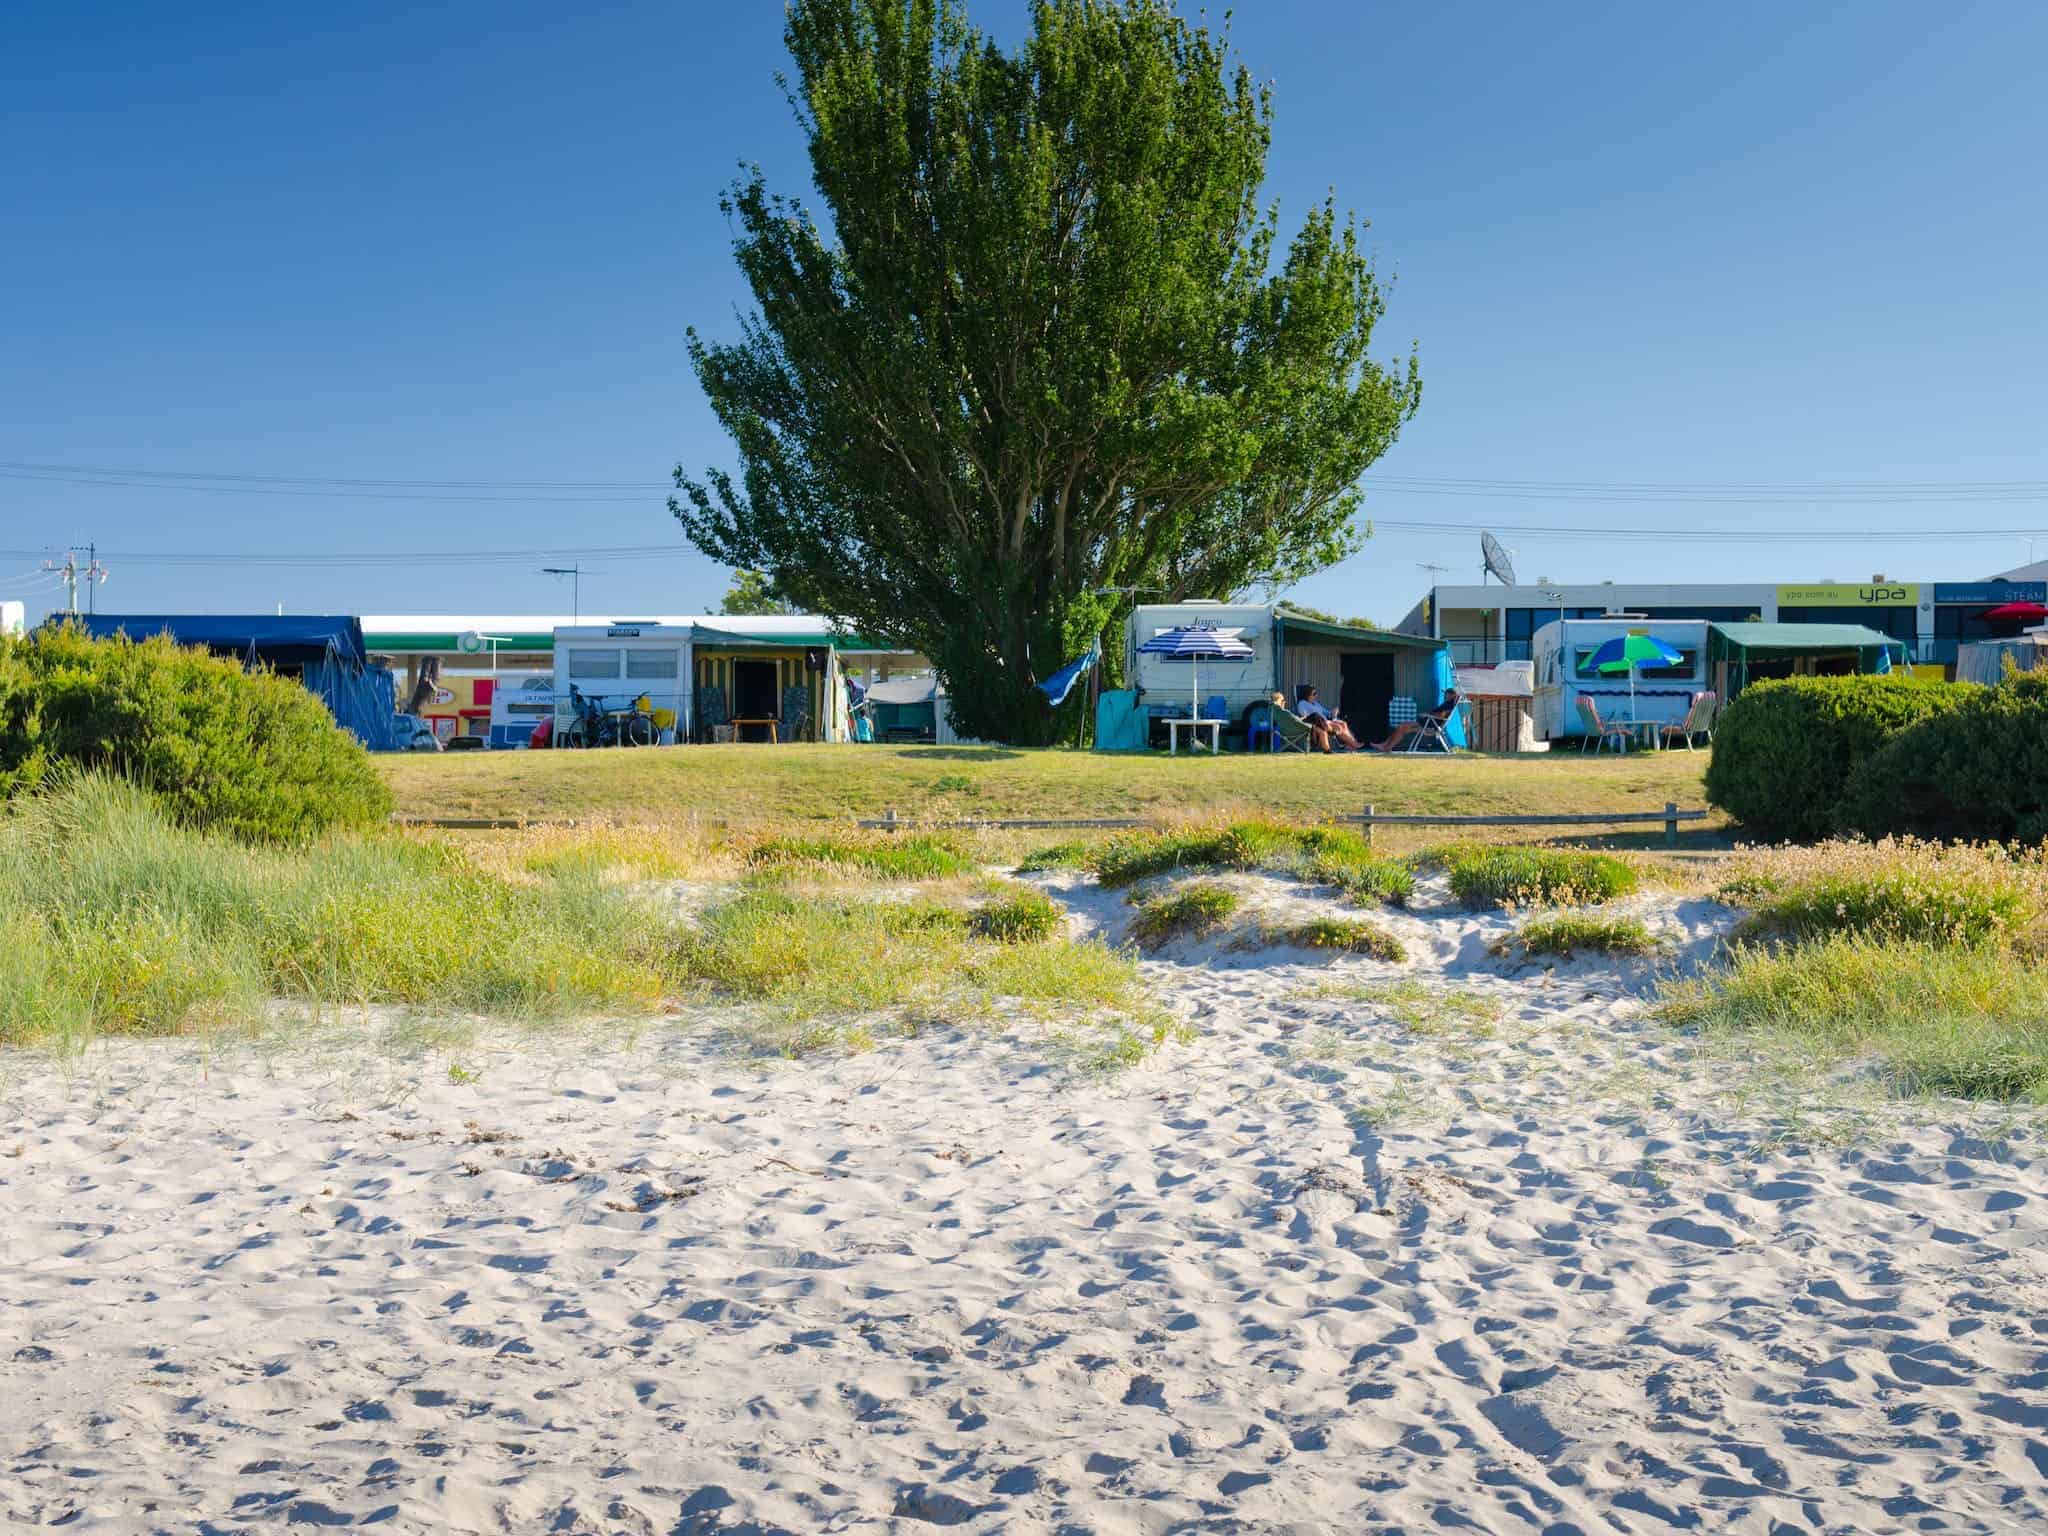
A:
[0, 776, 1171, 1061]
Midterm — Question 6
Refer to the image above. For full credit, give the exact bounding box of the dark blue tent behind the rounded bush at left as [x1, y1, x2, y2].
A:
[49, 612, 403, 752]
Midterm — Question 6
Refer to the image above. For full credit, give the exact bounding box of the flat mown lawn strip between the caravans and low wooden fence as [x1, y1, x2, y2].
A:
[379, 745, 1720, 846]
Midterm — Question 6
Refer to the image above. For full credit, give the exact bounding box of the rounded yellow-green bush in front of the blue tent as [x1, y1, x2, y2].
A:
[0, 629, 391, 842]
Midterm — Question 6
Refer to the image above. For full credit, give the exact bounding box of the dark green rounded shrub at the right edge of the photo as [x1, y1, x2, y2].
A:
[1839, 672, 2048, 842]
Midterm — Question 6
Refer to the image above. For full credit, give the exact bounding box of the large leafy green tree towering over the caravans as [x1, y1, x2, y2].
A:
[670, 0, 1421, 741]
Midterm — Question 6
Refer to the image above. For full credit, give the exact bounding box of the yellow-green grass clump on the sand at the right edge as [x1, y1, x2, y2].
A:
[1661, 934, 2048, 1104]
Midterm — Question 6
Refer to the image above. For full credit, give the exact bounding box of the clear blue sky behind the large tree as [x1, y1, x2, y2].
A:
[0, 0, 2048, 618]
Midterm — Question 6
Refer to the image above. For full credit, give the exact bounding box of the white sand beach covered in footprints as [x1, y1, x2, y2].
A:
[0, 877, 2048, 1536]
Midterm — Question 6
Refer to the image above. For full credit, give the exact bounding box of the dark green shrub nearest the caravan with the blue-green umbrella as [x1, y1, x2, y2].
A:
[1706, 678, 1974, 842]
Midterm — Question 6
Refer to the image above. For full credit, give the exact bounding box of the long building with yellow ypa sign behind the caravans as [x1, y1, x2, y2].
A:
[1401, 571, 2048, 668]
